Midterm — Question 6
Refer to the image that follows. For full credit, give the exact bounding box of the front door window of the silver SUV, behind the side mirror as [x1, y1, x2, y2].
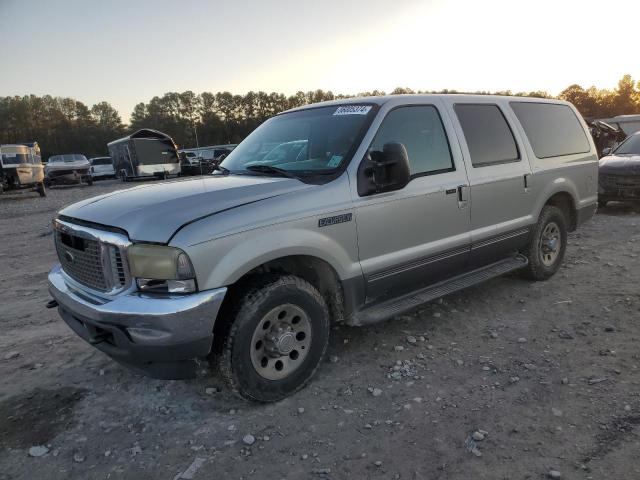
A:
[369, 105, 455, 177]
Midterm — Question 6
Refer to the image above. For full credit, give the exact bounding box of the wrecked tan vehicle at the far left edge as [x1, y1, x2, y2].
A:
[0, 143, 47, 197]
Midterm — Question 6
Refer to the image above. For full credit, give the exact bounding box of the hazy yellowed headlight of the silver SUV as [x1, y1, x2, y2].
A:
[128, 243, 196, 293]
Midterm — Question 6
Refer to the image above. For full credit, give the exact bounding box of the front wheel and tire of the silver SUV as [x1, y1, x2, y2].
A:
[219, 275, 330, 402]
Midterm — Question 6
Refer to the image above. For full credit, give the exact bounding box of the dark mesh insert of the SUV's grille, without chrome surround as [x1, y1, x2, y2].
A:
[55, 230, 107, 292]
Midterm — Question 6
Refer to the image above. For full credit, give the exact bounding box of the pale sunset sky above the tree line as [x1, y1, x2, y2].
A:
[0, 0, 640, 121]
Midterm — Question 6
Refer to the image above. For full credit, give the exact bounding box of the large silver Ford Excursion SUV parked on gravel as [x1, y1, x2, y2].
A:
[49, 95, 598, 401]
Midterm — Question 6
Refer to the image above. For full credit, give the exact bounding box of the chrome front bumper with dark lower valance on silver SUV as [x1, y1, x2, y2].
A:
[49, 265, 227, 380]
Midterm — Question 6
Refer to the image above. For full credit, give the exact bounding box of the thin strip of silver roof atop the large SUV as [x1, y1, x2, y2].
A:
[281, 93, 567, 113]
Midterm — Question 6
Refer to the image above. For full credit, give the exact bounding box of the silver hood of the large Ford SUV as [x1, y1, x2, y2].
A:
[60, 175, 313, 243]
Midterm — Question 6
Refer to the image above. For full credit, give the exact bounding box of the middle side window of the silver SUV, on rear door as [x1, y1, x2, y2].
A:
[454, 103, 520, 167]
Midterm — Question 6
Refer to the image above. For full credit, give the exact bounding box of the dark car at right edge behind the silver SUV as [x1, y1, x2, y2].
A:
[598, 131, 640, 208]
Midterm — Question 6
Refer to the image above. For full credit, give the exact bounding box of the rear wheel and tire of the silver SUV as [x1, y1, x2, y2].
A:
[522, 205, 567, 280]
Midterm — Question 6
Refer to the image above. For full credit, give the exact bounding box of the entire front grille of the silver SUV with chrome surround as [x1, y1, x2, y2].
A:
[54, 222, 129, 293]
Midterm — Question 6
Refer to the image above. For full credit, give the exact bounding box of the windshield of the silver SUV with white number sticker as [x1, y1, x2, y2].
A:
[221, 104, 375, 174]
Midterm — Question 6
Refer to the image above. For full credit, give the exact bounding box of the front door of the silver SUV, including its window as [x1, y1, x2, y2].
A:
[354, 104, 470, 302]
